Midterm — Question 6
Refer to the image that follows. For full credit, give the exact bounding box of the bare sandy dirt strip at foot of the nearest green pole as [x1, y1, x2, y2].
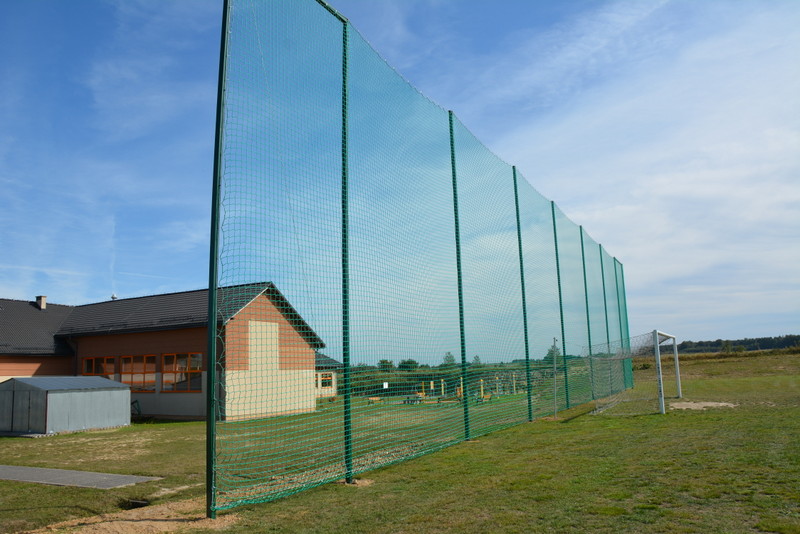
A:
[32, 498, 238, 534]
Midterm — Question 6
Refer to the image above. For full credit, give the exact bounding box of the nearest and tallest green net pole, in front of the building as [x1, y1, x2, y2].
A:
[206, 0, 230, 519]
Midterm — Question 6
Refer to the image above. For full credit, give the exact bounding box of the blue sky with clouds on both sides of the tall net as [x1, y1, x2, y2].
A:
[0, 0, 800, 340]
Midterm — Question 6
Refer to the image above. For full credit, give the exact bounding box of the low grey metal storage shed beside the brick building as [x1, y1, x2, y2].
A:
[0, 376, 131, 434]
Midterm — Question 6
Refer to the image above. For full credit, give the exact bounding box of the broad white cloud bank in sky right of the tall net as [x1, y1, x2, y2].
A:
[488, 5, 800, 339]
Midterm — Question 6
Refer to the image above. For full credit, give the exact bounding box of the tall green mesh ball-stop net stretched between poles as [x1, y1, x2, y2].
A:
[208, 0, 628, 513]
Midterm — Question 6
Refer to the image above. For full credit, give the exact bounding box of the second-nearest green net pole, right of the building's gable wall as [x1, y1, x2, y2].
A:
[340, 19, 353, 484]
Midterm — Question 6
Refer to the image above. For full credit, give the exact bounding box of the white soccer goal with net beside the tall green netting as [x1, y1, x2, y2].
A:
[586, 330, 682, 415]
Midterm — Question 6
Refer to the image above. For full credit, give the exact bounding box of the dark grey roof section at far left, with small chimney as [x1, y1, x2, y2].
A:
[0, 299, 73, 356]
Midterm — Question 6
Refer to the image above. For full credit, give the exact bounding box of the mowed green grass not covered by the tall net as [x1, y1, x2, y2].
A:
[0, 354, 800, 533]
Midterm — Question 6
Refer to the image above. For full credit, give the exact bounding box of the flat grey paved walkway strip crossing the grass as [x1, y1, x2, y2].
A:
[0, 465, 161, 489]
